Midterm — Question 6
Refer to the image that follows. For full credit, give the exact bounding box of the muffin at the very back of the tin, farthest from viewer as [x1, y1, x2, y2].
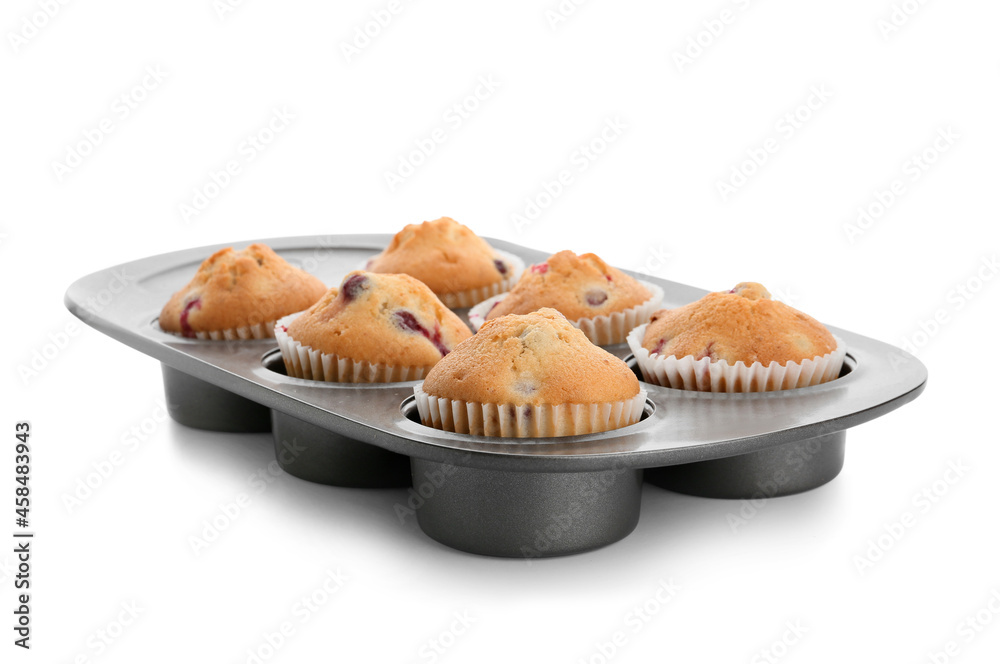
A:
[365, 217, 524, 309]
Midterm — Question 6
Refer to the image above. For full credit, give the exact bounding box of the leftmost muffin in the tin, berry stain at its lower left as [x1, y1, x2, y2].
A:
[159, 244, 326, 340]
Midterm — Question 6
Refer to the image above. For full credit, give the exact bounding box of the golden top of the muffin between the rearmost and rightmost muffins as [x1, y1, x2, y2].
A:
[486, 251, 653, 321]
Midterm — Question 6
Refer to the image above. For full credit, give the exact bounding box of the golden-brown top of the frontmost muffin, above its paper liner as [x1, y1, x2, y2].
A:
[423, 309, 639, 406]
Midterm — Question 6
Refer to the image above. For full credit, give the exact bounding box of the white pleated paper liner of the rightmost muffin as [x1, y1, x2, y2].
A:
[628, 324, 847, 393]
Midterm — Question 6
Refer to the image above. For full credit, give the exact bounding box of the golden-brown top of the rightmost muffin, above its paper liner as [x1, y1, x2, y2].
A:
[642, 282, 837, 366]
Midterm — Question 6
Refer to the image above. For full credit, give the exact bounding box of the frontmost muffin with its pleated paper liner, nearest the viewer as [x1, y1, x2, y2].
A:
[414, 308, 646, 438]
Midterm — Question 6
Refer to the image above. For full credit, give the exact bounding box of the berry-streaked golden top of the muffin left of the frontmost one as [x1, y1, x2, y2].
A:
[287, 270, 472, 367]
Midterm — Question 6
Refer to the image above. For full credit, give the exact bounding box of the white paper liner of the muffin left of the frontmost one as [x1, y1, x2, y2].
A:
[274, 311, 430, 383]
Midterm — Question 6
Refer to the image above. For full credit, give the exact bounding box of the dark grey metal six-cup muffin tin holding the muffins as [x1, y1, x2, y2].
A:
[65, 235, 927, 558]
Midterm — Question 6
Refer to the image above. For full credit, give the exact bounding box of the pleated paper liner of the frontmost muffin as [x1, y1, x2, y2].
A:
[413, 383, 646, 438]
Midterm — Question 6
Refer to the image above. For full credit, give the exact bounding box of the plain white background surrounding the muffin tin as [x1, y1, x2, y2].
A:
[0, 0, 1000, 663]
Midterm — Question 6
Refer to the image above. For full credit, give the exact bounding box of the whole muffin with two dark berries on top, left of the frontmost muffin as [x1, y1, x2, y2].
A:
[275, 270, 472, 383]
